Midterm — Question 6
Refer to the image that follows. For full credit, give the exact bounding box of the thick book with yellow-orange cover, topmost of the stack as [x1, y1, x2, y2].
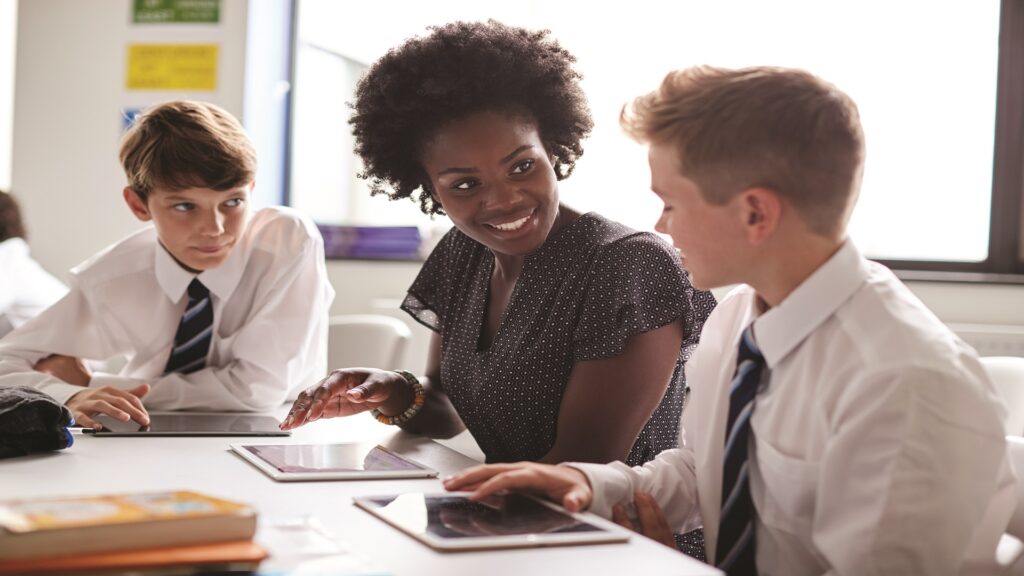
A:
[0, 491, 256, 560]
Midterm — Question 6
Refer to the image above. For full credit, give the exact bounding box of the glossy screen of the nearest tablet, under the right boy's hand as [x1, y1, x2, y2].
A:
[357, 493, 607, 540]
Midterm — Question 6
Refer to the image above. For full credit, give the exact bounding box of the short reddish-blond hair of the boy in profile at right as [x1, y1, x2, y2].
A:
[620, 67, 864, 237]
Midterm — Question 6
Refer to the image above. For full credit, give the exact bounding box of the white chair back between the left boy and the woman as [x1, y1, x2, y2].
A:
[327, 314, 412, 370]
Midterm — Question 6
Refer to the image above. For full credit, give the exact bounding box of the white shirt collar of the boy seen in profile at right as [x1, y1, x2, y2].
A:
[754, 240, 868, 368]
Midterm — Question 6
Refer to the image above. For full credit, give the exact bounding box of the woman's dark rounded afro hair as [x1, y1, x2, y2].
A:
[349, 20, 593, 214]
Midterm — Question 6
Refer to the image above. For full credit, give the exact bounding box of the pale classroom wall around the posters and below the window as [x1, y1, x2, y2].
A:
[9, 0, 1024, 368]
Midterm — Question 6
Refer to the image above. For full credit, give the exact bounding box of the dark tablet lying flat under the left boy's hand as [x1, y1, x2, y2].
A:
[82, 413, 292, 438]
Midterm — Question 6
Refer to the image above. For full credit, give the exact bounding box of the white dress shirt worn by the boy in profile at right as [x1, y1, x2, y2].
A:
[572, 242, 1016, 576]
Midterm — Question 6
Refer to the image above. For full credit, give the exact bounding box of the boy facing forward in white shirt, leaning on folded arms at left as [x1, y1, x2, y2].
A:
[0, 100, 334, 427]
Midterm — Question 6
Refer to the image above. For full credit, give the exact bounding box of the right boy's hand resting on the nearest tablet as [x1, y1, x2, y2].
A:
[444, 462, 594, 512]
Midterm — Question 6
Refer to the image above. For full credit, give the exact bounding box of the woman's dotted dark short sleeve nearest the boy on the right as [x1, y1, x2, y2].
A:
[573, 233, 715, 362]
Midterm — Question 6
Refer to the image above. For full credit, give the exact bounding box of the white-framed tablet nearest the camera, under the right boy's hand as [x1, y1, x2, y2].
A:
[352, 492, 630, 551]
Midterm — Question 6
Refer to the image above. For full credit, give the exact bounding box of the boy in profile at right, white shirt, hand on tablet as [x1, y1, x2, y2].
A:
[445, 68, 1014, 575]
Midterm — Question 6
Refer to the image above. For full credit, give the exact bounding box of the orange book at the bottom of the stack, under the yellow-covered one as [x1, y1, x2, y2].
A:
[0, 540, 267, 575]
